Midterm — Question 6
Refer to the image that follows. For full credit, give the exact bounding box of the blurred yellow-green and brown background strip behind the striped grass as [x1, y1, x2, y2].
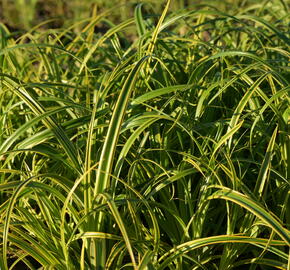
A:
[0, 0, 258, 31]
